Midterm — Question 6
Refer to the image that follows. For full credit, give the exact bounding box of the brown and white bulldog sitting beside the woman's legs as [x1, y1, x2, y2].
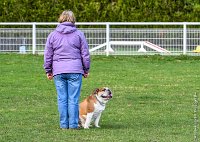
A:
[79, 87, 112, 129]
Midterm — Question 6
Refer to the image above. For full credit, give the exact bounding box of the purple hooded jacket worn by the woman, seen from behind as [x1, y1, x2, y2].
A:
[44, 22, 90, 75]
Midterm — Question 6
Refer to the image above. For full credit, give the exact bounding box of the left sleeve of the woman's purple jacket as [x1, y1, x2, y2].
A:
[43, 34, 53, 73]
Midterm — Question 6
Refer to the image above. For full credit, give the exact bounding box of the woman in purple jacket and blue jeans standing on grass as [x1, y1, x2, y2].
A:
[44, 11, 90, 129]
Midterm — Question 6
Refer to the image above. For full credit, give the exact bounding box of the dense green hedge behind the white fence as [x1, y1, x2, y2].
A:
[0, 0, 200, 22]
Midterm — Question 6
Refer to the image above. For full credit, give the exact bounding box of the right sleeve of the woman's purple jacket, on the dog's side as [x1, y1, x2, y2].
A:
[81, 33, 90, 73]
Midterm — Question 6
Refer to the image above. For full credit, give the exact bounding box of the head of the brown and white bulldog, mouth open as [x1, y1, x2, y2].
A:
[94, 87, 112, 103]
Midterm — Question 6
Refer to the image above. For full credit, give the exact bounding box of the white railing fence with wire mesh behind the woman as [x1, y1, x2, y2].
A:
[0, 22, 200, 55]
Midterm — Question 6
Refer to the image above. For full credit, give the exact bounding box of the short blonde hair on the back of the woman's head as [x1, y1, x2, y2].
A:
[58, 10, 76, 24]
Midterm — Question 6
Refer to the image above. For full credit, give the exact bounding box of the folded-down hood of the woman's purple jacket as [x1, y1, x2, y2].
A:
[56, 22, 77, 34]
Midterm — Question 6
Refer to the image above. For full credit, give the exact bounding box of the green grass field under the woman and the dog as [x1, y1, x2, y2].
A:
[0, 54, 200, 142]
